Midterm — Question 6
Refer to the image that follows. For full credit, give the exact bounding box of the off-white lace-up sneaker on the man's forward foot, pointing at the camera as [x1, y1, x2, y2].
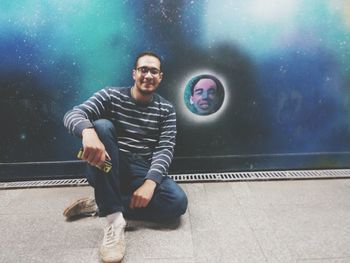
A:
[100, 222, 126, 263]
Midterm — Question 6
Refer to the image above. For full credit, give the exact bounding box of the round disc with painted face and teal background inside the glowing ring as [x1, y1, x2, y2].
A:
[185, 75, 224, 115]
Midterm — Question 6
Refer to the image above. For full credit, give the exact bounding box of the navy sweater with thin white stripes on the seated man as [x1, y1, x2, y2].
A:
[64, 87, 176, 183]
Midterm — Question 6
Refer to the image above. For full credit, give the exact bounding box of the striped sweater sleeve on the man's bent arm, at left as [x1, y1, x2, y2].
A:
[63, 88, 111, 137]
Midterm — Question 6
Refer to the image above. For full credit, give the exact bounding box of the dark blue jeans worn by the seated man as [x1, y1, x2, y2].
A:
[86, 119, 187, 221]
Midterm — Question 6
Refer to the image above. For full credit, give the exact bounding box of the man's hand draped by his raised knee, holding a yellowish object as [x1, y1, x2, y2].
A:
[81, 128, 111, 166]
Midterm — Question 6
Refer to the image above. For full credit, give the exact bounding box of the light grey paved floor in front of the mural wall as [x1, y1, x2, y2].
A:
[0, 179, 350, 263]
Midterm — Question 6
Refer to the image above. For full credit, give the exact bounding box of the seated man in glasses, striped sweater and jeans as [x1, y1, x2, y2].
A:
[64, 52, 187, 262]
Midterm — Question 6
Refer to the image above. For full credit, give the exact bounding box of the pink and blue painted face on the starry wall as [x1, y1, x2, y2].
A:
[191, 79, 217, 115]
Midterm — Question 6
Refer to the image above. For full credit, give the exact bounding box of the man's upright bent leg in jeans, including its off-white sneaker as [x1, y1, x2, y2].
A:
[86, 119, 126, 262]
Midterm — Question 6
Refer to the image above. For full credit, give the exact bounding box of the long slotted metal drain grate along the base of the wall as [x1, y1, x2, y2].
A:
[0, 169, 350, 189]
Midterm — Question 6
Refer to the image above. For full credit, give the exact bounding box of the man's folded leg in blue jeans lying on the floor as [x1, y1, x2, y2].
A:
[123, 157, 188, 222]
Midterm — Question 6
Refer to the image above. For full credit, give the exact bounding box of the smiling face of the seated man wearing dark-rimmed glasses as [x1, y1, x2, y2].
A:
[132, 55, 163, 95]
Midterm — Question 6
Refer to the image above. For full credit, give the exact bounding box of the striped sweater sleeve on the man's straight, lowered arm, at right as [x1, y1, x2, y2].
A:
[146, 104, 176, 183]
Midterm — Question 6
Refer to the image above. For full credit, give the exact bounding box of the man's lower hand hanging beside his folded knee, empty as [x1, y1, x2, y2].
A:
[130, 179, 157, 209]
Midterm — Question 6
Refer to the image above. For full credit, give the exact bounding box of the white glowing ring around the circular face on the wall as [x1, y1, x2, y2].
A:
[178, 69, 230, 123]
